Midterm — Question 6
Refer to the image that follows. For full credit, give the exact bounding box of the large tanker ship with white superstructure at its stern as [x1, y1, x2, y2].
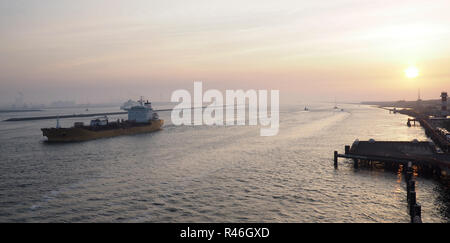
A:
[41, 98, 164, 142]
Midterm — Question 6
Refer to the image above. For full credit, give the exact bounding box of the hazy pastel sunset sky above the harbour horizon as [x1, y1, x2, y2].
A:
[0, 0, 450, 104]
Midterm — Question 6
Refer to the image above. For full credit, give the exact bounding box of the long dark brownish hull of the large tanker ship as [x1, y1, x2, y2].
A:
[41, 120, 164, 142]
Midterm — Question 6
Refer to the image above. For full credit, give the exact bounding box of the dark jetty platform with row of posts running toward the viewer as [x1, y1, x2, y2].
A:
[334, 139, 450, 223]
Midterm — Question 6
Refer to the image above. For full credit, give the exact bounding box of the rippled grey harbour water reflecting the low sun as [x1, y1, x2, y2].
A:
[0, 104, 449, 222]
